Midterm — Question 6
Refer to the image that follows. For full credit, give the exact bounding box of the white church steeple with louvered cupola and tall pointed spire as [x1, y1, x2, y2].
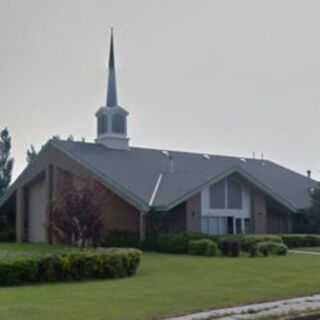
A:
[96, 28, 129, 150]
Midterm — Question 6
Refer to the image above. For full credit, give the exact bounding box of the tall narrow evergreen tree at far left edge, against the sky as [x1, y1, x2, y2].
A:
[0, 128, 13, 197]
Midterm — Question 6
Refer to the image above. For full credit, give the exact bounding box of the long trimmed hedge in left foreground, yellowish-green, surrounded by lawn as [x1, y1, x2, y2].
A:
[0, 249, 142, 285]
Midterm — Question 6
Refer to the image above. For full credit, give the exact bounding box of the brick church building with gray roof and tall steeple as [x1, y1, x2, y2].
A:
[0, 33, 317, 243]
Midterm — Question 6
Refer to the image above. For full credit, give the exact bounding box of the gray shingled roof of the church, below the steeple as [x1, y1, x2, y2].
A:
[50, 140, 317, 211]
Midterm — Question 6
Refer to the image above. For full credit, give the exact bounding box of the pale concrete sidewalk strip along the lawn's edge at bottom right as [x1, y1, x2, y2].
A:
[165, 294, 320, 320]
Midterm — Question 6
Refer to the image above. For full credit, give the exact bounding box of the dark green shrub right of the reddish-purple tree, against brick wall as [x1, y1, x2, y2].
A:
[104, 230, 141, 248]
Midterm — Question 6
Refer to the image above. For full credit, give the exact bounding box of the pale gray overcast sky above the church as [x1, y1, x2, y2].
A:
[0, 0, 320, 179]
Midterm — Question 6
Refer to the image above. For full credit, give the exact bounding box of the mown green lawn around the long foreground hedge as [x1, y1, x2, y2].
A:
[0, 244, 320, 320]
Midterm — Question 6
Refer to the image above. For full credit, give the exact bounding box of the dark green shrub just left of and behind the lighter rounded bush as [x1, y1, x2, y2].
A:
[156, 232, 208, 253]
